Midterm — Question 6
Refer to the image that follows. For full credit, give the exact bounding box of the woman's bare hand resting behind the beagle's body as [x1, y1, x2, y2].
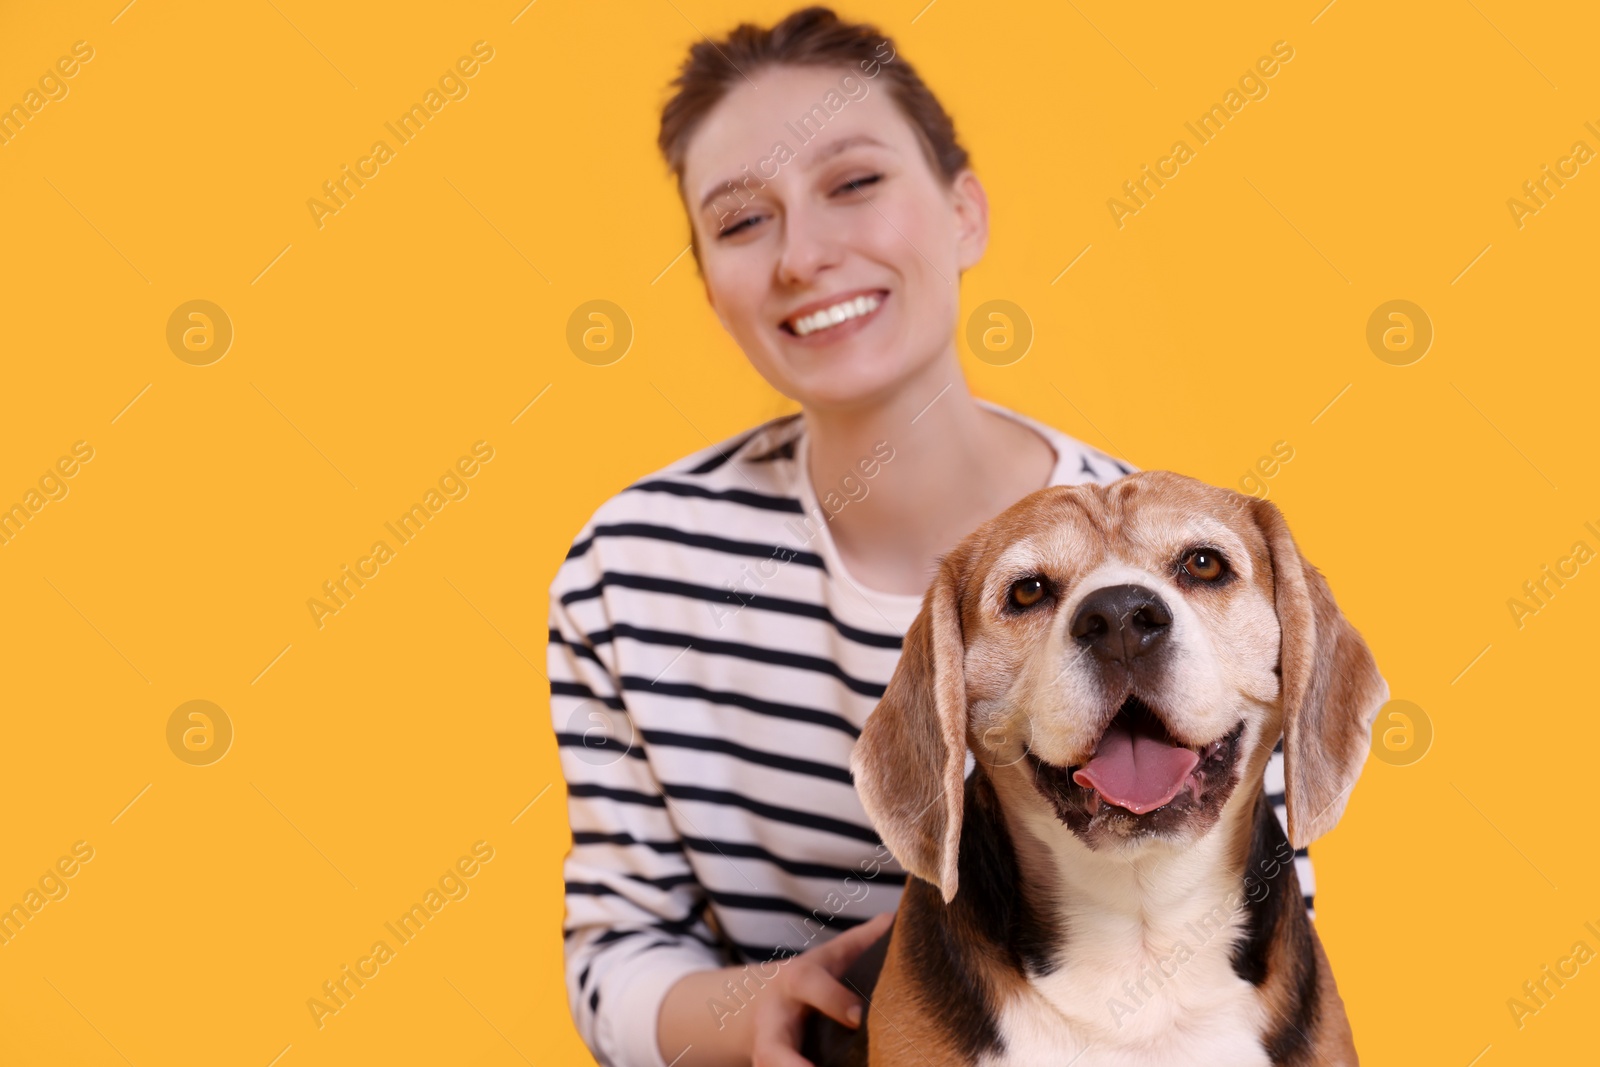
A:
[750, 912, 894, 1067]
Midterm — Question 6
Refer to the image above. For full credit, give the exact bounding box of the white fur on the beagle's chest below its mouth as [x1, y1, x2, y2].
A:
[981, 812, 1270, 1067]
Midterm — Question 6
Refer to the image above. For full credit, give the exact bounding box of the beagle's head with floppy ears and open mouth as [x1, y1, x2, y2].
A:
[851, 470, 1389, 901]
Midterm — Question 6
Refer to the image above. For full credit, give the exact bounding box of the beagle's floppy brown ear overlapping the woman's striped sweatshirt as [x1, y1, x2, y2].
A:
[850, 545, 970, 904]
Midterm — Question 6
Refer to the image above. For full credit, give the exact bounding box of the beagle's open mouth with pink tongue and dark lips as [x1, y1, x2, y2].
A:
[1027, 696, 1245, 832]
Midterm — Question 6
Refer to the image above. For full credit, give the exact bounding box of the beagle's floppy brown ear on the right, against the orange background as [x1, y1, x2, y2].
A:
[1251, 499, 1389, 848]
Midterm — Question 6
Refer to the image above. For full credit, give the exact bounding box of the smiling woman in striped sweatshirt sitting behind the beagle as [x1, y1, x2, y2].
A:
[549, 8, 1310, 1067]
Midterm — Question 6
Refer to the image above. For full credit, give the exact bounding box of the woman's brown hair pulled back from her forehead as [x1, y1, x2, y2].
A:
[656, 6, 968, 271]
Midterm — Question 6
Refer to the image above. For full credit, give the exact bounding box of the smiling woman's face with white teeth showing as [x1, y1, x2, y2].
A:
[683, 67, 989, 408]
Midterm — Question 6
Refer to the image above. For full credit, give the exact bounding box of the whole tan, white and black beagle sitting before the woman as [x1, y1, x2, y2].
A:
[851, 470, 1389, 1067]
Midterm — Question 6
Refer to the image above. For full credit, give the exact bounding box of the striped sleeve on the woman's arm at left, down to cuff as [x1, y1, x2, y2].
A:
[547, 526, 726, 1067]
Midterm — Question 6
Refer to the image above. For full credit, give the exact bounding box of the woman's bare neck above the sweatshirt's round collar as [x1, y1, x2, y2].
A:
[805, 350, 1056, 595]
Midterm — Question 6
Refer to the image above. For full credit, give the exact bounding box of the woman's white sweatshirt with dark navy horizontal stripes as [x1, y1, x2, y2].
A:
[547, 400, 1314, 1067]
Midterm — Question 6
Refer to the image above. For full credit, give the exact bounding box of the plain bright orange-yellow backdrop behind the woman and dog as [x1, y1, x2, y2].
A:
[0, 0, 1600, 1067]
